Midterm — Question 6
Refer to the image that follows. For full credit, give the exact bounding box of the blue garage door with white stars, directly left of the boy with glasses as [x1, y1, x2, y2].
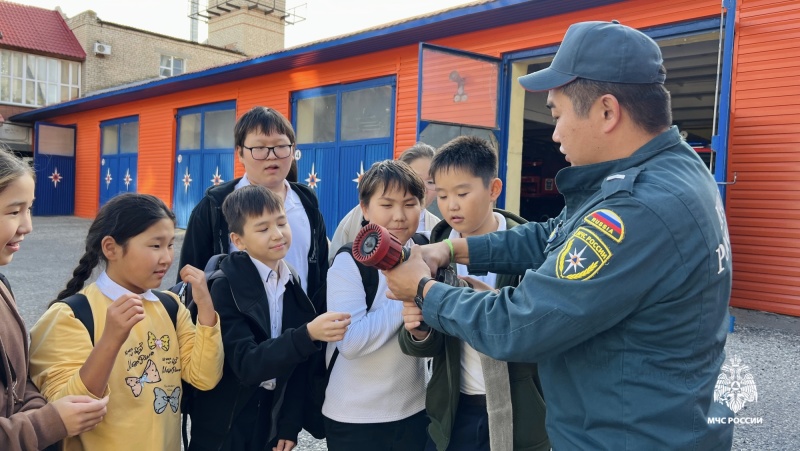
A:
[173, 101, 236, 228]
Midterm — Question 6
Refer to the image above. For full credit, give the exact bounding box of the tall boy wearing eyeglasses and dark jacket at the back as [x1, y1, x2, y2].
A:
[179, 106, 328, 308]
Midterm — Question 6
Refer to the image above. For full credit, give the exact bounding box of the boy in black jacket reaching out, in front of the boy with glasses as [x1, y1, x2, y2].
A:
[189, 185, 350, 451]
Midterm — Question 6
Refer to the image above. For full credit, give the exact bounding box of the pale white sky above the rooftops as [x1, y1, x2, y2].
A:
[11, 0, 470, 47]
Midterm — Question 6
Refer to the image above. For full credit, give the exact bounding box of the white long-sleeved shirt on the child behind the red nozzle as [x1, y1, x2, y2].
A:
[322, 253, 425, 423]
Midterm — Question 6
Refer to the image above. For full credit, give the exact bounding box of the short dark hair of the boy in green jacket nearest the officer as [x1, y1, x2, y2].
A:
[431, 136, 497, 188]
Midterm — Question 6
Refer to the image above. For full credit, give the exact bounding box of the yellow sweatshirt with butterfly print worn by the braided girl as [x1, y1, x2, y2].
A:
[31, 284, 224, 451]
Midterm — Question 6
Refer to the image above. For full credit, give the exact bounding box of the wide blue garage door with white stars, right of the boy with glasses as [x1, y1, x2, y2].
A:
[292, 77, 396, 236]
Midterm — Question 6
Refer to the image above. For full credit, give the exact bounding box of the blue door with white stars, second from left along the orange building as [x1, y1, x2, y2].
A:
[100, 116, 139, 206]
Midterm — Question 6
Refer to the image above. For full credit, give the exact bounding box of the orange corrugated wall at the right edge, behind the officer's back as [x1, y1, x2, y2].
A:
[727, 0, 800, 316]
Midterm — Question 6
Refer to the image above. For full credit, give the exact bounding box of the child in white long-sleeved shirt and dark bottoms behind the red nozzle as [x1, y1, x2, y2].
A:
[322, 160, 428, 451]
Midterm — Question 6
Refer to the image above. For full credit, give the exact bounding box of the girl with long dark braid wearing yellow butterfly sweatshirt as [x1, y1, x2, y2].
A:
[31, 194, 223, 451]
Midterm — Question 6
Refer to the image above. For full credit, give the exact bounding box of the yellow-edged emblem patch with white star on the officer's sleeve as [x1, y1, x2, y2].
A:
[556, 227, 611, 280]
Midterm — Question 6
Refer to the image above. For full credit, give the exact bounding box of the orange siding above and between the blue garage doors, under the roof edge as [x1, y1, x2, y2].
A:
[45, 0, 720, 204]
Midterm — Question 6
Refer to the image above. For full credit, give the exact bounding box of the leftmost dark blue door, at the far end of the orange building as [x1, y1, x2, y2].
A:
[33, 122, 75, 216]
